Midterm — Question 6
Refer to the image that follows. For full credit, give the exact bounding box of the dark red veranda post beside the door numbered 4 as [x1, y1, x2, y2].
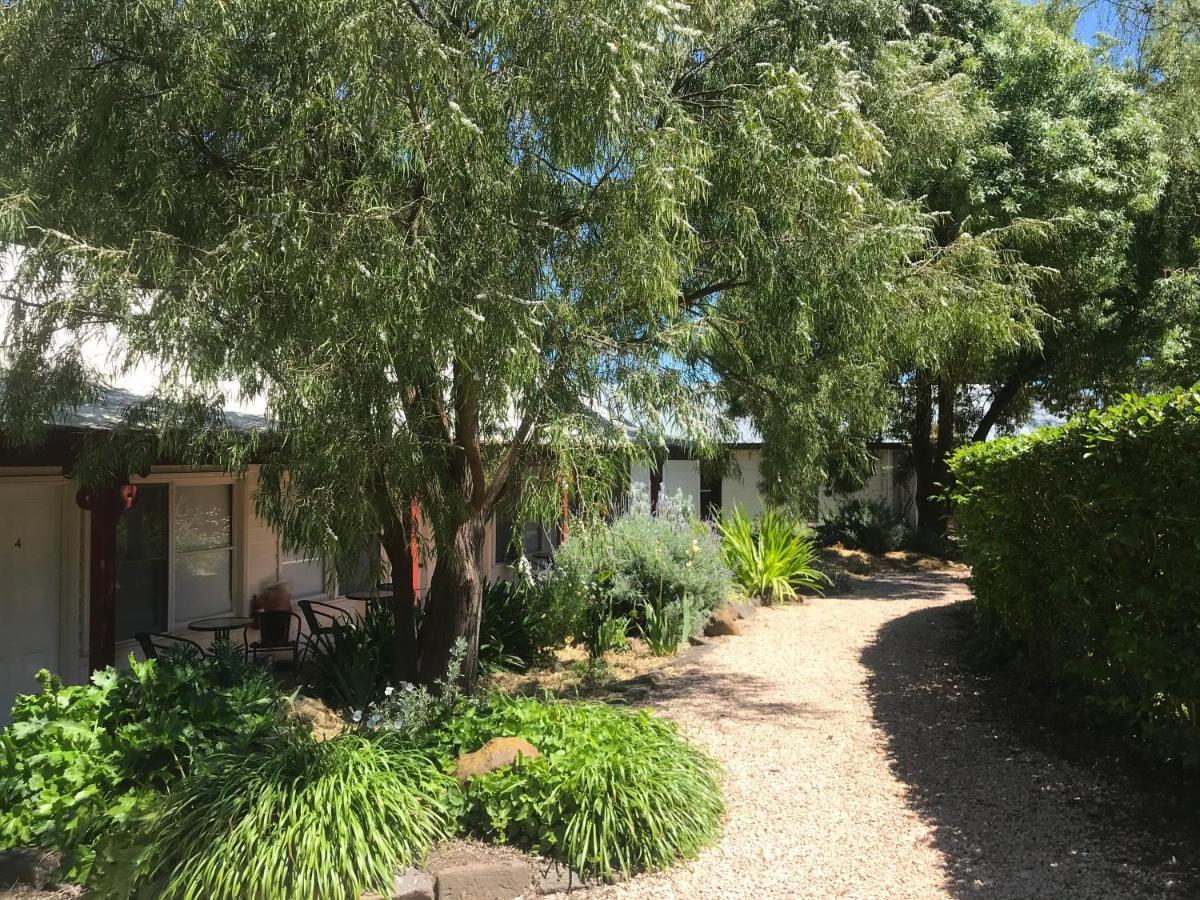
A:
[76, 485, 138, 672]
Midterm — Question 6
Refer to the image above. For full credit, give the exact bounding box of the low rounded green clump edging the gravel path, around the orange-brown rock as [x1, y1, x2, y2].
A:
[448, 696, 722, 876]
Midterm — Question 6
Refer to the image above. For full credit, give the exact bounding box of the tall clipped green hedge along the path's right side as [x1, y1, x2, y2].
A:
[950, 389, 1200, 763]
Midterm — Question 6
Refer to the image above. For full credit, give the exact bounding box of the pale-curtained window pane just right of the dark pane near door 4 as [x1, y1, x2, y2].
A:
[175, 485, 233, 622]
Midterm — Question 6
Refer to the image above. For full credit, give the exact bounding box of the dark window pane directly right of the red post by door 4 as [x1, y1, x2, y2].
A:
[116, 485, 169, 641]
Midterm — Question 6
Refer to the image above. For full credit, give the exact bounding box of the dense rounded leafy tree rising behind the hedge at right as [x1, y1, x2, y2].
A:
[878, 0, 1165, 529]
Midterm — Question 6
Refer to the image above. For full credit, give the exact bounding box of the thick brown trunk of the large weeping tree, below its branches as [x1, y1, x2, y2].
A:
[418, 515, 485, 690]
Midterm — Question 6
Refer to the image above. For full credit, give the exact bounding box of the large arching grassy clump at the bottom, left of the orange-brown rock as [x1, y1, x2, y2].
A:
[97, 733, 457, 900]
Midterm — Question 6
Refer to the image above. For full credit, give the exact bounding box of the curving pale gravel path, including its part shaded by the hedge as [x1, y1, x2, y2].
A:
[586, 572, 1196, 900]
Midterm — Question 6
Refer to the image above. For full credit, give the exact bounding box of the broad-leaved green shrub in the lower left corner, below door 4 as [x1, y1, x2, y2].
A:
[0, 659, 287, 881]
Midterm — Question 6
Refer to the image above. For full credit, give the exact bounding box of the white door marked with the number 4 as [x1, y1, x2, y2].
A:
[0, 484, 62, 725]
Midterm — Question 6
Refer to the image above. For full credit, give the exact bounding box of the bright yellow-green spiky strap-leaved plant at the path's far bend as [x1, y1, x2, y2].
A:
[716, 508, 830, 604]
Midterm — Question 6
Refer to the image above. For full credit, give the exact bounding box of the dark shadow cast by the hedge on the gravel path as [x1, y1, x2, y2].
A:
[862, 602, 1200, 900]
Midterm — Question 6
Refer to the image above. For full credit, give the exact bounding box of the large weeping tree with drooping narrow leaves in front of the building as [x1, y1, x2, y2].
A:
[0, 0, 1032, 679]
